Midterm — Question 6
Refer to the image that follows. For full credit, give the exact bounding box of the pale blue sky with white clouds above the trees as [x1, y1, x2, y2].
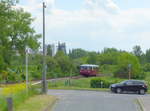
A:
[17, 0, 150, 51]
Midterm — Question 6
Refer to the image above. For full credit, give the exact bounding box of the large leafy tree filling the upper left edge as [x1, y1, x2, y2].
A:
[0, 0, 41, 81]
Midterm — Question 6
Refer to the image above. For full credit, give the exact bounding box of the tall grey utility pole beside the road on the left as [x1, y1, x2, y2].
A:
[42, 2, 47, 94]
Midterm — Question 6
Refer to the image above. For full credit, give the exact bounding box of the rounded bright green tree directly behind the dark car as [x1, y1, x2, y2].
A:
[114, 52, 144, 79]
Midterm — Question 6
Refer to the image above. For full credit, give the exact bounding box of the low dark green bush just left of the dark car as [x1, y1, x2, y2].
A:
[90, 77, 123, 88]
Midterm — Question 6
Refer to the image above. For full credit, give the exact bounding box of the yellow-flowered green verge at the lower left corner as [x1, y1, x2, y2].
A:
[0, 84, 40, 111]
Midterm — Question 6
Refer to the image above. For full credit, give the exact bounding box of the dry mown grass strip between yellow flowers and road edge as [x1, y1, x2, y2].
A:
[16, 95, 56, 111]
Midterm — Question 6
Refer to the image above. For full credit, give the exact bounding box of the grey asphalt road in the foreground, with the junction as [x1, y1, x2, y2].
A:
[48, 90, 149, 111]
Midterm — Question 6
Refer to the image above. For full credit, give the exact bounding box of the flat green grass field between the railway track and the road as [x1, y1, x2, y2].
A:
[48, 77, 122, 90]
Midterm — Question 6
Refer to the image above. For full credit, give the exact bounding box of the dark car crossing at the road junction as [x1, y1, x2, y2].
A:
[110, 80, 147, 94]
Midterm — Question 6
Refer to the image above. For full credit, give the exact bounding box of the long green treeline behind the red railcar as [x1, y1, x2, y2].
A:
[30, 46, 150, 79]
